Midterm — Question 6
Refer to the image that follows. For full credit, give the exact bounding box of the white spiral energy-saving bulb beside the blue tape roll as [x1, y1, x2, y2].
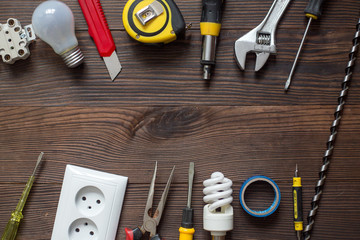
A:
[203, 172, 234, 240]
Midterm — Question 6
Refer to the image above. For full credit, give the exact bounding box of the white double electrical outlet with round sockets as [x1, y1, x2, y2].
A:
[51, 165, 128, 240]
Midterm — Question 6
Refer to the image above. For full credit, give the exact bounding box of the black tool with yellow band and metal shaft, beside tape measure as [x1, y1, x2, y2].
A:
[200, 0, 223, 80]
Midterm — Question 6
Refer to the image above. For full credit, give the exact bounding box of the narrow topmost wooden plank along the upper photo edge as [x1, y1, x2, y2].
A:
[0, 0, 360, 31]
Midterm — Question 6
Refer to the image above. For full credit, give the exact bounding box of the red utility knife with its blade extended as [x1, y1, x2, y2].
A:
[78, 0, 121, 81]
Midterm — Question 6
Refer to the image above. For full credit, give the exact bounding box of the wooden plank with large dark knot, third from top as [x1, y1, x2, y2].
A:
[0, 105, 360, 183]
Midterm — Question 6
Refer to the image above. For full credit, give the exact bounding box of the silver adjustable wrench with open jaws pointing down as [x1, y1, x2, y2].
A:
[235, 0, 291, 71]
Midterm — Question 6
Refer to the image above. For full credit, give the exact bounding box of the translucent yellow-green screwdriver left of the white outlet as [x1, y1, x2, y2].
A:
[1, 152, 44, 240]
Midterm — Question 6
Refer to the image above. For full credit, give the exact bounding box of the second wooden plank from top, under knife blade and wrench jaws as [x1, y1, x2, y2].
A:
[0, 30, 360, 106]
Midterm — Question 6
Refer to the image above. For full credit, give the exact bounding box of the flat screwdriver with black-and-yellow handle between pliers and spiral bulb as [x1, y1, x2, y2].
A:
[179, 162, 195, 240]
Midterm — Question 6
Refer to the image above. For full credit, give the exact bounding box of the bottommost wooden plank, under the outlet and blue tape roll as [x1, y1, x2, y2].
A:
[0, 181, 360, 240]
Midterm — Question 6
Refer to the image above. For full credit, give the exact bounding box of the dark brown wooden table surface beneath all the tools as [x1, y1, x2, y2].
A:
[0, 0, 360, 239]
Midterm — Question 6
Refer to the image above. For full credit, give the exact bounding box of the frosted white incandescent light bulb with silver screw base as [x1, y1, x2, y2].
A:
[32, 0, 84, 68]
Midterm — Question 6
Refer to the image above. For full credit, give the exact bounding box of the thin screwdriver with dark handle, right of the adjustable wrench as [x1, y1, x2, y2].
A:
[285, 0, 325, 91]
